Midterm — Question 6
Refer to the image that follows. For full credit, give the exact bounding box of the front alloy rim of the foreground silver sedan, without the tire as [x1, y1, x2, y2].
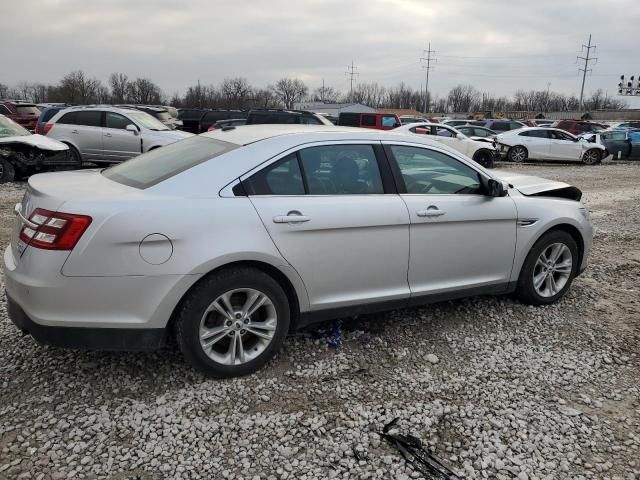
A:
[533, 243, 573, 298]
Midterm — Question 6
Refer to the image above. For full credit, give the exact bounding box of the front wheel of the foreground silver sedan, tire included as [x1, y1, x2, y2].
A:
[516, 230, 579, 305]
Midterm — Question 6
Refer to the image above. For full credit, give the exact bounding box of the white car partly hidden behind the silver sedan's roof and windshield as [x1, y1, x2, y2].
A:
[393, 122, 497, 168]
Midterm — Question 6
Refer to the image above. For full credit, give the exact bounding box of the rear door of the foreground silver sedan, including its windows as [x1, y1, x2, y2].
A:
[243, 142, 409, 310]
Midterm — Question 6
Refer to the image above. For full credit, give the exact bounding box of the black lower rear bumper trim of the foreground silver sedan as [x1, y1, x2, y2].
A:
[7, 295, 166, 351]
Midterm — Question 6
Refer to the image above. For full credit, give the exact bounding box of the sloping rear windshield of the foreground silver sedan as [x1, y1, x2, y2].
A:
[102, 137, 239, 189]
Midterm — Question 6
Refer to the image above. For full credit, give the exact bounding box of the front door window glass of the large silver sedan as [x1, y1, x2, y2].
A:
[390, 145, 482, 195]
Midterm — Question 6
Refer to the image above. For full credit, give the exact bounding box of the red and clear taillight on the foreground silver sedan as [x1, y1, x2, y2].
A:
[20, 208, 91, 250]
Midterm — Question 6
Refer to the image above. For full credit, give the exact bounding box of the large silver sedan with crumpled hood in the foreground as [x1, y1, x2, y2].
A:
[3, 125, 592, 377]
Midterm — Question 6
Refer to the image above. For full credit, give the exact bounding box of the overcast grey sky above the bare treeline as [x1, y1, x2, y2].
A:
[0, 0, 640, 106]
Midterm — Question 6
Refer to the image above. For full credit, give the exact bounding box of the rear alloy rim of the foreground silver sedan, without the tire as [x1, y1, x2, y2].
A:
[199, 288, 278, 365]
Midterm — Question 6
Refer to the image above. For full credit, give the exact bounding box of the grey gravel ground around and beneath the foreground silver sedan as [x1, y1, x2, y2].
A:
[0, 164, 640, 480]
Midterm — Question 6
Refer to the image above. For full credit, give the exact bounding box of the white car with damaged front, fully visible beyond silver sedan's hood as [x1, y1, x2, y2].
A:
[497, 127, 606, 165]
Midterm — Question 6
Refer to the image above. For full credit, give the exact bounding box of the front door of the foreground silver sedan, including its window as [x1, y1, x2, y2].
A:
[387, 142, 517, 298]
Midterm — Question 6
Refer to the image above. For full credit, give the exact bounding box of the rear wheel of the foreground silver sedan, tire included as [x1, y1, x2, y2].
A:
[175, 267, 290, 378]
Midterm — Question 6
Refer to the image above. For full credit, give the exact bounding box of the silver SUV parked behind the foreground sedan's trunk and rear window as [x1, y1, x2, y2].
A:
[44, 106, 192, 163]
